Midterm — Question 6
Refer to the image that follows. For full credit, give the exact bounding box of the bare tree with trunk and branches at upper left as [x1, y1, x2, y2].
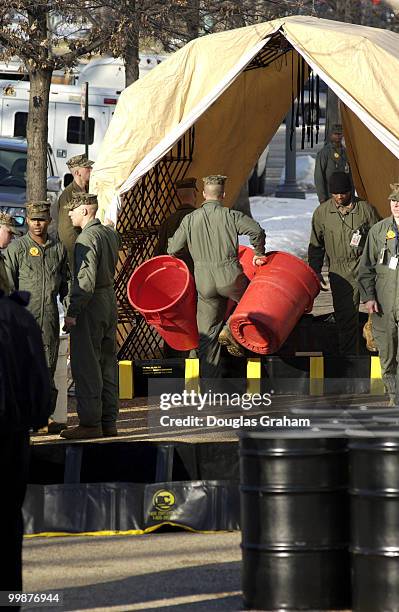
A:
[0, 0, 123, 200]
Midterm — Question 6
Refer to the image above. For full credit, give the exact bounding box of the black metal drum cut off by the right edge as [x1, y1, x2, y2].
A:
[348, 427, 399, 612]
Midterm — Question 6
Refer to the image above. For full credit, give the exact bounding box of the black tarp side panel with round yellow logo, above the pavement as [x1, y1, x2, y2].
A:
[23, 481, 239, 534]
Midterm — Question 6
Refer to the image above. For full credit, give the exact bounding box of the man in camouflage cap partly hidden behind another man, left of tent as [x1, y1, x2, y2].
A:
[58, 155, 94, 272]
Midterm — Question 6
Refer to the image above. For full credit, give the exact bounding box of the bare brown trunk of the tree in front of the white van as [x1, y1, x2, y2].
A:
[26, 68, 53, 200]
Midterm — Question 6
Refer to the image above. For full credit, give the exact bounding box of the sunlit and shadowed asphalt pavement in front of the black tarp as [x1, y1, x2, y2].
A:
[22, 531, 243, 612]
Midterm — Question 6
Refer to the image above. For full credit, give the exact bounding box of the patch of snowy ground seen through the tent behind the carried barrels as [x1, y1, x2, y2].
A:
[240, 193, 319, 257]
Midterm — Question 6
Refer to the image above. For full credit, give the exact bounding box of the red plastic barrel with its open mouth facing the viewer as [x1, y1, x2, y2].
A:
[127, 255, 198, 351]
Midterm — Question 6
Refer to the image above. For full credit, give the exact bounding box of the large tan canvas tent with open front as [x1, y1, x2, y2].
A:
[90, 16, 399, 224]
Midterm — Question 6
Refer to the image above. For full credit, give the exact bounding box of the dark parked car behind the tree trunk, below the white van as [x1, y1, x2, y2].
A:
[0, 136, 61, 228]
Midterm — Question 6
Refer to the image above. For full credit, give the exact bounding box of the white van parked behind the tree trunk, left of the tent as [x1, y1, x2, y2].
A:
[0, 80, 120, 187]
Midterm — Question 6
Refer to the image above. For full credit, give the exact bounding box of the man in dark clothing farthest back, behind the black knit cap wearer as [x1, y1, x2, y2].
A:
[314, 123, 352, 202]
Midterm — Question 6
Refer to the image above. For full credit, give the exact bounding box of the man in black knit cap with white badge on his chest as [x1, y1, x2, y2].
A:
[308, 172, 380, 355]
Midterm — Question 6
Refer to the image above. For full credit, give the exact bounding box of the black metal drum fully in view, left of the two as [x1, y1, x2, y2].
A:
[240, 429, 350, 610]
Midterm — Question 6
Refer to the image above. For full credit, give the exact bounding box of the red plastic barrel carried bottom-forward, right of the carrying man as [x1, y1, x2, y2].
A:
[230, 251, 320, 355]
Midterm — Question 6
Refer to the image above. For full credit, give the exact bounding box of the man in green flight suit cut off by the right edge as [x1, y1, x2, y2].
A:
[358, 183, 399, 406]
